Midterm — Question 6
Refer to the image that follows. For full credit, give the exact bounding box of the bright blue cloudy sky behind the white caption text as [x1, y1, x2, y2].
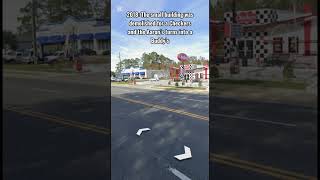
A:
[111, 0, 209, 71]
